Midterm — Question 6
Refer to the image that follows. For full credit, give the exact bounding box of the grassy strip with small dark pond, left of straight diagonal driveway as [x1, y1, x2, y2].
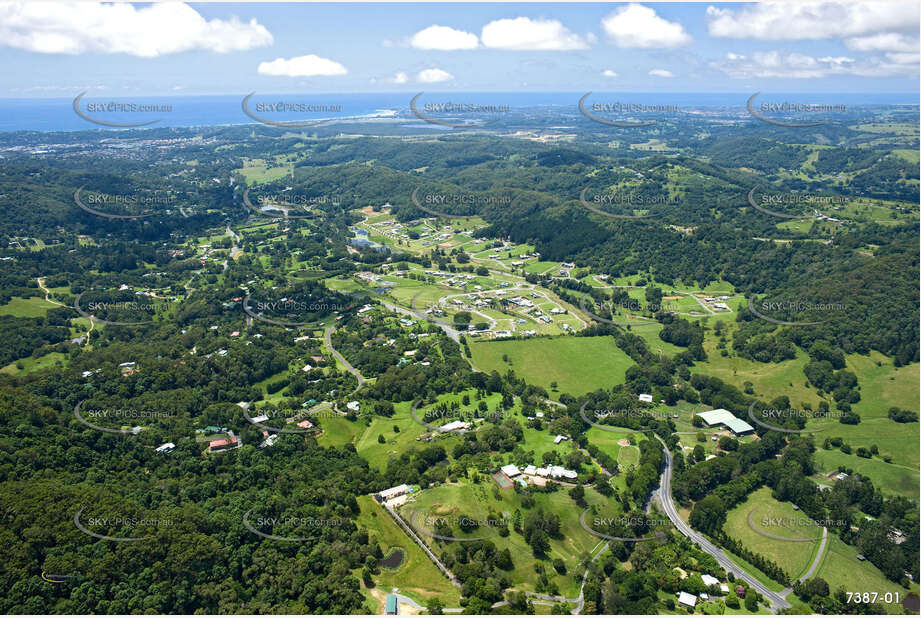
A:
[356, 496, 460, 607]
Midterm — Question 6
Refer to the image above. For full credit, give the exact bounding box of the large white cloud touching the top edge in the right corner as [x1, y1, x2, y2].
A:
[707, 2, 921, 41]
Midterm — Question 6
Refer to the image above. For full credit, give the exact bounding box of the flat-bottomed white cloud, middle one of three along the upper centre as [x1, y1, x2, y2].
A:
[480, 17, 593, 51]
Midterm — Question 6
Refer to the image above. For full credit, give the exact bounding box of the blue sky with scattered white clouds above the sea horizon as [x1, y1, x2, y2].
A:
[0, 1, 919, 98]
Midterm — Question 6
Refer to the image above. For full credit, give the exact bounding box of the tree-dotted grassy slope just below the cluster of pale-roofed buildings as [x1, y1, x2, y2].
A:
[400, 475, 620, 597]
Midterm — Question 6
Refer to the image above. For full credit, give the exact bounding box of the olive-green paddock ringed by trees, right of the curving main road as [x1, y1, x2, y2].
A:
[723, 487, 822, 579]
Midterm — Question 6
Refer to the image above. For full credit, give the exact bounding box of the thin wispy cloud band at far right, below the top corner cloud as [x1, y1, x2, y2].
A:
[710, 51, 918, 79]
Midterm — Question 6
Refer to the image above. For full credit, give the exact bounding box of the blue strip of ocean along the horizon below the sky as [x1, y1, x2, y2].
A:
[0, 91, 918, 132]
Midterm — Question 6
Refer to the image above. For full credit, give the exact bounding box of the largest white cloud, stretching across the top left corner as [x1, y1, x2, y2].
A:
[0, 1, 273, 58]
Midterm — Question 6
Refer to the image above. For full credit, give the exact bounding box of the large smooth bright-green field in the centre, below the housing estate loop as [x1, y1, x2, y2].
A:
[470, 337, 633, 396]
